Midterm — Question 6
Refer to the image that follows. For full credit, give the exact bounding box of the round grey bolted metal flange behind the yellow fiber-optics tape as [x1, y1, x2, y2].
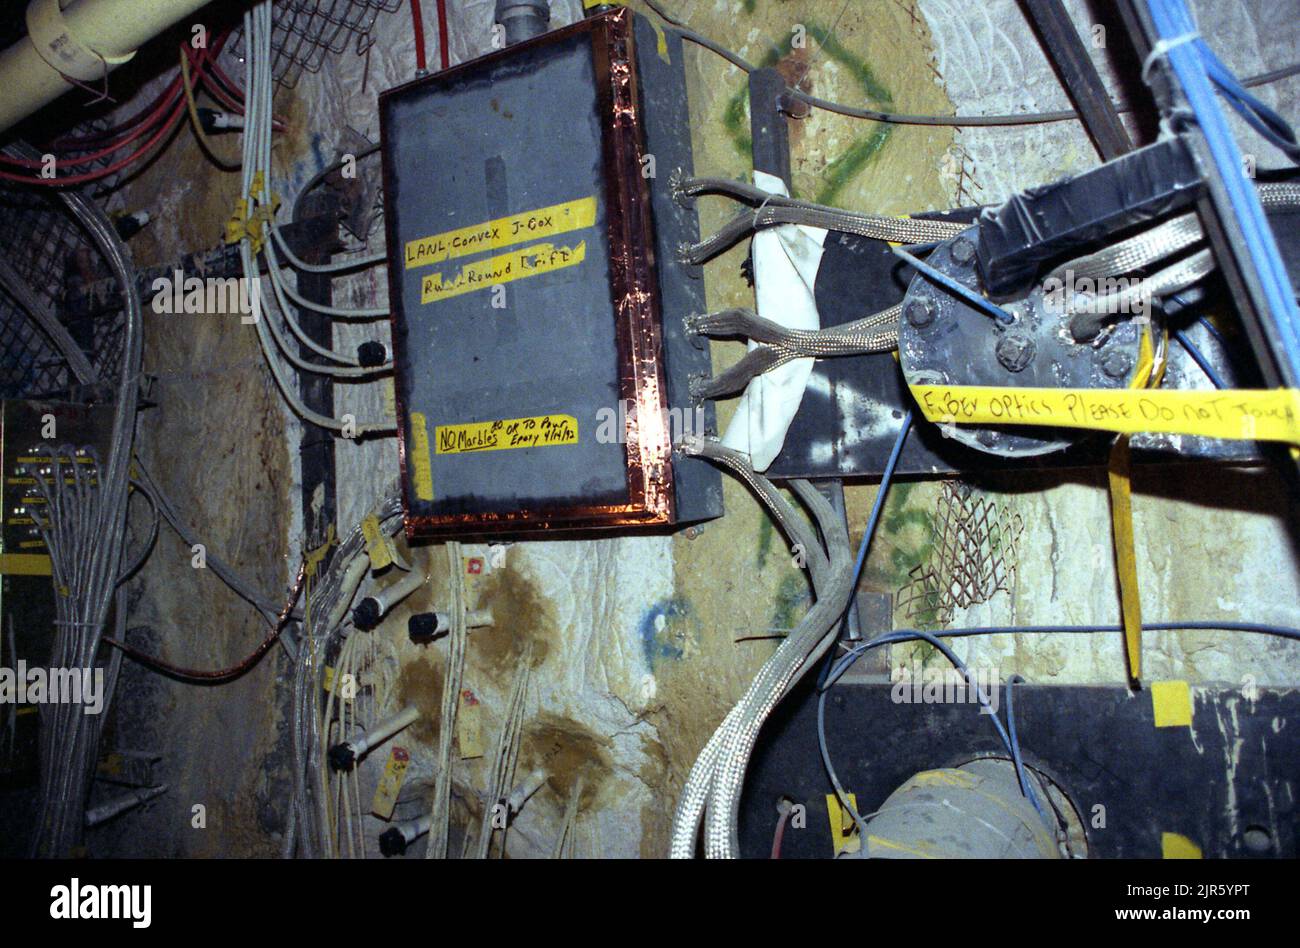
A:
[898, 225, 1141, 458]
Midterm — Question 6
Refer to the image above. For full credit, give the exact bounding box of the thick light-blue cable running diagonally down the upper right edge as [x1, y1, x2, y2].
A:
[1147, 0, 1300, 378]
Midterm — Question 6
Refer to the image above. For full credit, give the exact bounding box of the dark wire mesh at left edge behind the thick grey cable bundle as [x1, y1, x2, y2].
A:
[0, 187, 125, 398]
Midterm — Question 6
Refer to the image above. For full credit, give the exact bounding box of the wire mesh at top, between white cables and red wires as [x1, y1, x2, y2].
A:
[234, 0, 403, 88]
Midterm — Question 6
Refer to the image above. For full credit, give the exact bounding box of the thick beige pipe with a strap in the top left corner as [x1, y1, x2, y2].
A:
[0, 0, 208, 131]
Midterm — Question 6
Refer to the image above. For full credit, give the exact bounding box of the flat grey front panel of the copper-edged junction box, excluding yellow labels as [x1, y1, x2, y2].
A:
[385, 34, 628, 516]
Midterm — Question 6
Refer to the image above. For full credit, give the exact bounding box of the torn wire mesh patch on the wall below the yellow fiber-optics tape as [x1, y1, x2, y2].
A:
[897, 481, 1024, 628]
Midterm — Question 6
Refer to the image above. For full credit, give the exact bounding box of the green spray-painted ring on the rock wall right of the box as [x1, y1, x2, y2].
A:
[723, 19, 893, 204]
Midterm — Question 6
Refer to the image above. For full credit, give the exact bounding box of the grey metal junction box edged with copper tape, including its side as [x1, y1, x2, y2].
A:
[380, 9, 722, 538]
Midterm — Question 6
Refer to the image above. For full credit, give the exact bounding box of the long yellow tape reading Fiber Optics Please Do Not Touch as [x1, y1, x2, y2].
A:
[911, 385, 1300, 445]
